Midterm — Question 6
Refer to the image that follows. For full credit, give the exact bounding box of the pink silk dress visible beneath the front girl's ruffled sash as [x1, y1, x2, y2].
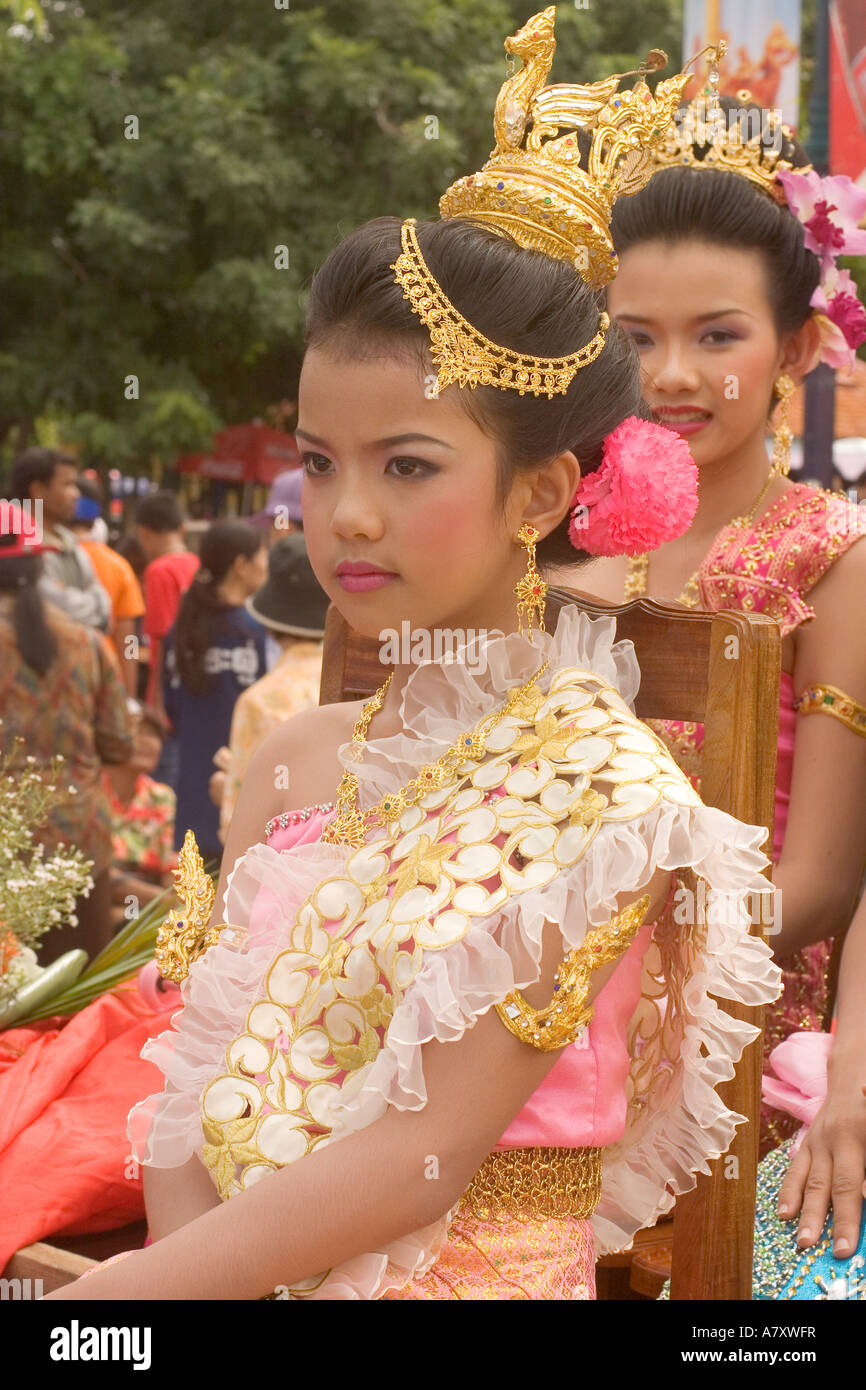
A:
[263, 794, 656, 1300]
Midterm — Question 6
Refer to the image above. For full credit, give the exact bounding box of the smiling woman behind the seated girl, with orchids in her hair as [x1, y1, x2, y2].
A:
[547, 74, 866, 1273]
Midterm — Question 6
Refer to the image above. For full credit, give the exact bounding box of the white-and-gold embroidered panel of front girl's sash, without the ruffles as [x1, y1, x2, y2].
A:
[195, 667, 701, 1198]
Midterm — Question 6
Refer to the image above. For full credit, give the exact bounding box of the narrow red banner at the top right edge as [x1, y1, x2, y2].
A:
[830, 0, 866, 188]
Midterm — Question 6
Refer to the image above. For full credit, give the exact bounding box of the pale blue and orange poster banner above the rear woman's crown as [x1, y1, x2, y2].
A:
[683, 0, 800, 131]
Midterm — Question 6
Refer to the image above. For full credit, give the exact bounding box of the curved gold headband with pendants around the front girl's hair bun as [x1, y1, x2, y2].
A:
[391, 217, 610, 399]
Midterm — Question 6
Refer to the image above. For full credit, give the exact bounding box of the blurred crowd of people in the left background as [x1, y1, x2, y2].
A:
[0, 448, 328, 965]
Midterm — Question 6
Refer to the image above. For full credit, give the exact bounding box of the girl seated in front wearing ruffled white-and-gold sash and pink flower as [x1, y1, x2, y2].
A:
[44, 10, 778, 1300]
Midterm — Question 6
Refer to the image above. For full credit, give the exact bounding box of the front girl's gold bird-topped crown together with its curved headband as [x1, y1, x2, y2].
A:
[392, 6, 706, 398]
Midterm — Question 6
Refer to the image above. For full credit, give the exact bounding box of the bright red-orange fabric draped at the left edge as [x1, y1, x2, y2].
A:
[0, 984, 177, 1270]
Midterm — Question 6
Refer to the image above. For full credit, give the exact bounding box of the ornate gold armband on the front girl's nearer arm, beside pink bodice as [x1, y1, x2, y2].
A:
[496, 894, 649, 1052]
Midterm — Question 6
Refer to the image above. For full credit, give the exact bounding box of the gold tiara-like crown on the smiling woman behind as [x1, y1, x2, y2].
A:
[652, 39, 812, 206]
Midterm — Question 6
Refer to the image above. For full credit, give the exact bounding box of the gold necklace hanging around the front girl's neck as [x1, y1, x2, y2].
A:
[322, 662, 549, 849]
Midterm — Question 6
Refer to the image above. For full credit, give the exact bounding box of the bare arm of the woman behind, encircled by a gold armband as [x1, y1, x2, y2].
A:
[770, 542, 866, 956]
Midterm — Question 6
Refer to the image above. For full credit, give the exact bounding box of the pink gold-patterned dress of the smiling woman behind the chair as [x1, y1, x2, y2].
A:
[646, 484, 866, 1155]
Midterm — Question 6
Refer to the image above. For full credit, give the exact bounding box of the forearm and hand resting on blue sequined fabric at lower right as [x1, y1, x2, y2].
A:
[778, 898, 866, 1257]
